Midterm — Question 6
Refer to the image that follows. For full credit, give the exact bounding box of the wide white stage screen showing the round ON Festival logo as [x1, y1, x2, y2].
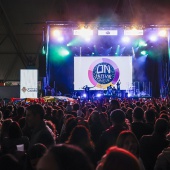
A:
[74, 56, 132, 90]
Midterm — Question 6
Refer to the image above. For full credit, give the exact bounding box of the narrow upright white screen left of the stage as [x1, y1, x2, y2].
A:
[20, 69, 38, 98]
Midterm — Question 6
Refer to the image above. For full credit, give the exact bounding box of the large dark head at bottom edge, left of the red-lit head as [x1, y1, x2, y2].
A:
[37, 144, 93, 170]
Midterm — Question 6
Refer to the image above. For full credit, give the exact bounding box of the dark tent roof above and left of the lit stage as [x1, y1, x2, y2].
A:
[0, 0, 170, 81]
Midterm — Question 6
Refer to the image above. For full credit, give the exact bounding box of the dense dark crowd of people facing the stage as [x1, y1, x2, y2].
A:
[0, 97, 170, 170]
